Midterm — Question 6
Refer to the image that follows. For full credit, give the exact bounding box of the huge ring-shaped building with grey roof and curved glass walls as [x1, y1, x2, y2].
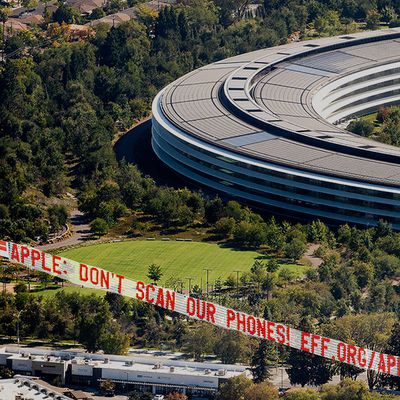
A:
[152, 29, 400, 230]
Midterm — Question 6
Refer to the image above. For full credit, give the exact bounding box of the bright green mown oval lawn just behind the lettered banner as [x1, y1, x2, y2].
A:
[54, 240, 307, 288]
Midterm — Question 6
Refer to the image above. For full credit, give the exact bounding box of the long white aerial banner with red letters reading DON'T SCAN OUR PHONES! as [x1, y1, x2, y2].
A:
[0, 241, 400, 377]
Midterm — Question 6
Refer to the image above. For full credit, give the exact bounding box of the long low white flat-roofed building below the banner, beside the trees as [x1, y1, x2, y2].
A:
[0, 347, 248, 397]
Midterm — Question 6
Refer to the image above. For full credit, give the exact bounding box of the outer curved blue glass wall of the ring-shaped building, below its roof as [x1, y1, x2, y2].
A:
[152, 104, 400, 230]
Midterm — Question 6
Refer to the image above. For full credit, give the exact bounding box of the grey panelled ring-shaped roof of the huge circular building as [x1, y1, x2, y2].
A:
[161, 29, 400, 188]
